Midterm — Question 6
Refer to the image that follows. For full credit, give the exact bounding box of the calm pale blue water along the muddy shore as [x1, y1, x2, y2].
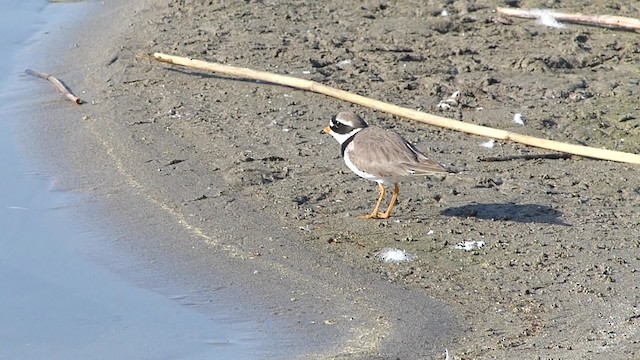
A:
[0, 0, 265, 360]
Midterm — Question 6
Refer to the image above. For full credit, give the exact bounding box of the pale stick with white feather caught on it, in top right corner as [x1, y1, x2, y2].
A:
[496, 7, 640, 32]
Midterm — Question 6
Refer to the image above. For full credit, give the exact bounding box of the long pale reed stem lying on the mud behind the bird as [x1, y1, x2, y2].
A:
[153, 53, 640, 164]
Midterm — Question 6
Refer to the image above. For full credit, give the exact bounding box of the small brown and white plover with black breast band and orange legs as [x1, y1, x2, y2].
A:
[322, 112, 449, 219]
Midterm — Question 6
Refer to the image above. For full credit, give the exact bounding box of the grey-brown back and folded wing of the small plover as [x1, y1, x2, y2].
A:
[351, 127, 448, 177]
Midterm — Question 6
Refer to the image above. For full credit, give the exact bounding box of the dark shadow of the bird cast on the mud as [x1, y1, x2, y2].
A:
[440, 203, 571, 226]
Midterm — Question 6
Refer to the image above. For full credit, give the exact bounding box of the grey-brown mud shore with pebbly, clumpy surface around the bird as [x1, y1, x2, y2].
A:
[42, 0, 640, 359]
